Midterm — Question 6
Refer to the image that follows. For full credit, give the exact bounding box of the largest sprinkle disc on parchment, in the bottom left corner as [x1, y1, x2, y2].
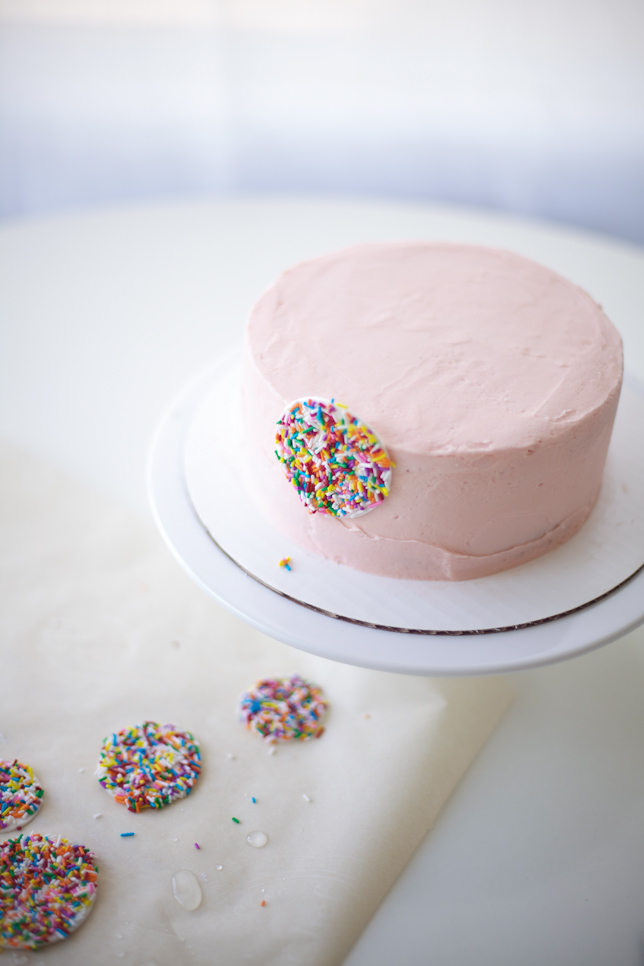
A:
[0, 835, 98, 951]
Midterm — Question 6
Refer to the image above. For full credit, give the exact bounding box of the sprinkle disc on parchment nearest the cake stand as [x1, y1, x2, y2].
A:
[239, 674, 327, 742]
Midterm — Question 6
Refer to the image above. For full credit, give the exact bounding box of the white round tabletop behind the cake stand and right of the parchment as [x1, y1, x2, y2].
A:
[0, 199, 644, 966]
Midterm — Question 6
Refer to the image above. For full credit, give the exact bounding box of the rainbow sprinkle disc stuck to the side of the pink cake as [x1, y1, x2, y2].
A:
[275, 398, 393, 517]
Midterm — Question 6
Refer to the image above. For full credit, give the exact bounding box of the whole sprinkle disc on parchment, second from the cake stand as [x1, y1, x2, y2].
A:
[96, 721, 201, 812]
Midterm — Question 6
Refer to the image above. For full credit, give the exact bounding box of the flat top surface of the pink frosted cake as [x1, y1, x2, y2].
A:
[247, 242, 622, 453]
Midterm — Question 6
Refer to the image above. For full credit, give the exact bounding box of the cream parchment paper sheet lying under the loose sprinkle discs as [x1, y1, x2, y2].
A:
[0, 445, 509, 966]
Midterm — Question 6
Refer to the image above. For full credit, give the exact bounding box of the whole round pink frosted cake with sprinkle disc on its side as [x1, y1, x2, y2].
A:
[243, 243, 622, 580]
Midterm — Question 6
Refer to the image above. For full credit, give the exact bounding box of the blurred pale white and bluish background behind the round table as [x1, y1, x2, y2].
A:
[0, 0, 644, 242]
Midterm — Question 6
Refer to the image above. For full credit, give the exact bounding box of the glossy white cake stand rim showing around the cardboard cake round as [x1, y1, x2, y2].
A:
[148, 363, 644, 675]
